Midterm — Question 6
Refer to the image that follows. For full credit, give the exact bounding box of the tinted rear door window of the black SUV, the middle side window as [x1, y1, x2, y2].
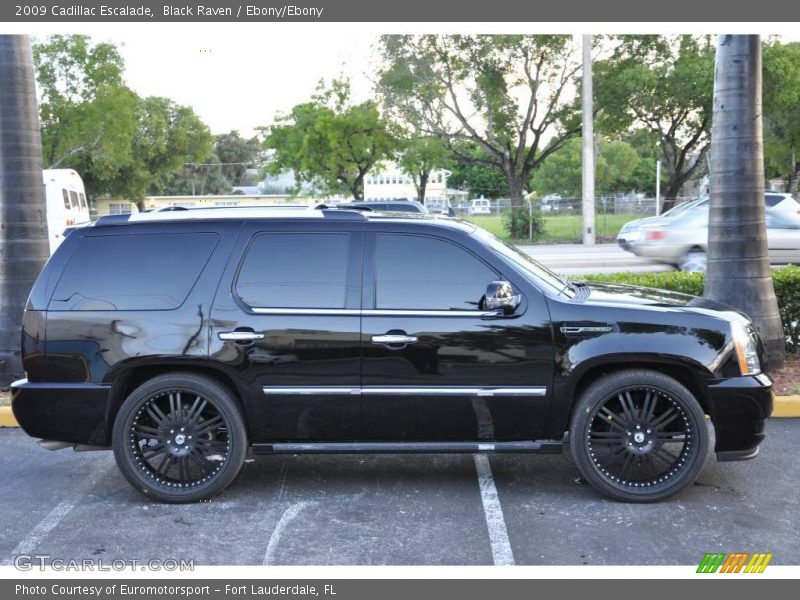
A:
[236, 232, 350, 309]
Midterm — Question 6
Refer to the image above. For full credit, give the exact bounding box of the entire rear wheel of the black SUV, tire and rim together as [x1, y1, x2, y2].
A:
[112, 373, 248, 503]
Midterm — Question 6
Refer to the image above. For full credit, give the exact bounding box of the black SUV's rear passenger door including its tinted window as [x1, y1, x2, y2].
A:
[210, 222, 363, 443]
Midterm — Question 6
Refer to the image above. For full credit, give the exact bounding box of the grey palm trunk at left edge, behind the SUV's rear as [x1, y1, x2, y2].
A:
[0, 35, 49, 387]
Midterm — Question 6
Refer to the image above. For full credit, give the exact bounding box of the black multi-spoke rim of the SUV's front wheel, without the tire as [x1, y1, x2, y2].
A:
[586, 387, 697, 490]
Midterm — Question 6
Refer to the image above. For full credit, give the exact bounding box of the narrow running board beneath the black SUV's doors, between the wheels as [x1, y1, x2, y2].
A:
[253, 440, 564, 454]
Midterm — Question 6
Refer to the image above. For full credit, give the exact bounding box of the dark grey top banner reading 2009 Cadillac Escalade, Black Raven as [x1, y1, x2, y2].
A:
[0, 0, 800, 23]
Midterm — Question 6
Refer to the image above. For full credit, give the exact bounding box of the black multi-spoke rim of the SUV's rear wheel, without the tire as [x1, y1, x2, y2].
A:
[130, 390, 231, 488]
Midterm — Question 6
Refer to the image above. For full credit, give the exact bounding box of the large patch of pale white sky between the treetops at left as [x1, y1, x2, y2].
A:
[109, 32, 378, 136]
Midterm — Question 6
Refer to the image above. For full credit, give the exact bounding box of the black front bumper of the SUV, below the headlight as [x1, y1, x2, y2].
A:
[707, 373, 773, 461]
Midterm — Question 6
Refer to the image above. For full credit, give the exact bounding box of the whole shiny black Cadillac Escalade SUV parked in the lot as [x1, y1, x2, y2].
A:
[13, 209, 772, 502]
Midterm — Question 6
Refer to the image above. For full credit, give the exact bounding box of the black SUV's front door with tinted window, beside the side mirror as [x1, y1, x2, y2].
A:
[362, 232, 552, 441]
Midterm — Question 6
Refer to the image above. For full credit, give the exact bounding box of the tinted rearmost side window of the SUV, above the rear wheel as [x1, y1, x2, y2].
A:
[49, 233, 218, 310]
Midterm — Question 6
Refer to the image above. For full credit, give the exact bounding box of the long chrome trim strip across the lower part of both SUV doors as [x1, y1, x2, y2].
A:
[262, 385, 547, 397]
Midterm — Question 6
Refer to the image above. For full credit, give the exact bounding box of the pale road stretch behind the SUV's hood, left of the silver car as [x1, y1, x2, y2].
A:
[518, 244, 673, 275]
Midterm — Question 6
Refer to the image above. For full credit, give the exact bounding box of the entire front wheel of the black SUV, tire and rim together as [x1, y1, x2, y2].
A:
[569, 369, 709, 502]
